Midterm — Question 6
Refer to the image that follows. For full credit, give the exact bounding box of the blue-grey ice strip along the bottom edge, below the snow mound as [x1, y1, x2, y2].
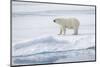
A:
[13, 49, 95, 65]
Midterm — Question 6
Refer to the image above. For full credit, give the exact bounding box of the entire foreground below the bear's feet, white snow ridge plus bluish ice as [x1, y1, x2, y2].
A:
[12, 35, 95, 65]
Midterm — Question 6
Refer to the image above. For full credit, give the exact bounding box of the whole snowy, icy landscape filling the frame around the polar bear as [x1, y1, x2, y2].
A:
[12, 2, 95, 65]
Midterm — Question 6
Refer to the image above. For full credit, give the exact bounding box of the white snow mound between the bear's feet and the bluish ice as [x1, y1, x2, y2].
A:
[13, 36, 95, 56]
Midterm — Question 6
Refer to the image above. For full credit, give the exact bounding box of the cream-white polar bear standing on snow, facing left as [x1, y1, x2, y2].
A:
[53, 17, 80, 35]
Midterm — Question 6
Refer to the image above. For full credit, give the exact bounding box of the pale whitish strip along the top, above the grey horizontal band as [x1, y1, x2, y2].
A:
[12, 2, 95, 12]
